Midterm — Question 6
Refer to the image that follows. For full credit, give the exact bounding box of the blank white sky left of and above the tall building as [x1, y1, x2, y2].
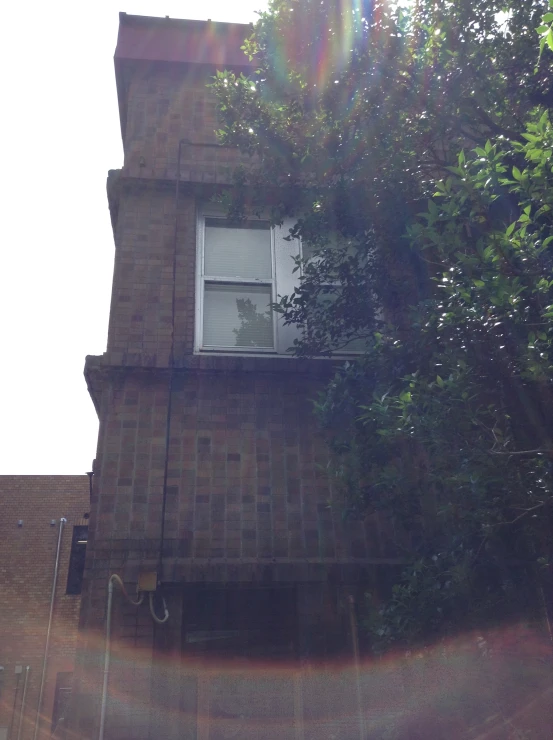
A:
[0, 0, 266, 475]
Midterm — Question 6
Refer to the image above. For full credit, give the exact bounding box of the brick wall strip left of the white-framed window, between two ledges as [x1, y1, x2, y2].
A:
[108, 187, 196, 367]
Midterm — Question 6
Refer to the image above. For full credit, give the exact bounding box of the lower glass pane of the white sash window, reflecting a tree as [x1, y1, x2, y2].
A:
[203, 283, 273, 347]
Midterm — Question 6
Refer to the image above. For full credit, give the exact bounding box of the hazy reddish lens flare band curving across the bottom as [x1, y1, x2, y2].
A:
[52, 625, 553, 740]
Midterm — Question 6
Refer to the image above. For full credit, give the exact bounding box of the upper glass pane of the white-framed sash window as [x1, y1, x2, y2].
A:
[204, 218, 273, 278]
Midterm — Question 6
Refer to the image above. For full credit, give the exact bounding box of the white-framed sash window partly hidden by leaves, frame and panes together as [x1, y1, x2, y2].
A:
[196, 208, 300, 354]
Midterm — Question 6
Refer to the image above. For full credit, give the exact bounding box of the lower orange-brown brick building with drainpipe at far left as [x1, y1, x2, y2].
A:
[0, 475, 89, 740]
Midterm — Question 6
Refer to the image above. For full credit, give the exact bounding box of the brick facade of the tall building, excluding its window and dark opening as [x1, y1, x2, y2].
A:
[71, 16, 406, 740]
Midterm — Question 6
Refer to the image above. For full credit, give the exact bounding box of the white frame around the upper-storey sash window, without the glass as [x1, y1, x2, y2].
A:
[194, 204, 301, 357]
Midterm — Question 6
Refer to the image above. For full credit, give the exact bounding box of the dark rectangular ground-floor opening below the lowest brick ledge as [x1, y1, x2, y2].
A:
[182, 584, 298, 661]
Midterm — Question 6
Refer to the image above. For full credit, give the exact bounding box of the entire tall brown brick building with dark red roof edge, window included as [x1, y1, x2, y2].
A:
[70, 14, 406, 740]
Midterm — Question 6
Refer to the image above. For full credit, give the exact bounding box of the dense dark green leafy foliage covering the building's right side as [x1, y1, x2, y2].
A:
[214, 0, 553, 647]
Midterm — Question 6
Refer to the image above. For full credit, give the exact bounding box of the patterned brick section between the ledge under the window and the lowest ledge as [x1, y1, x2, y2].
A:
[85, 372, 390, 562]
